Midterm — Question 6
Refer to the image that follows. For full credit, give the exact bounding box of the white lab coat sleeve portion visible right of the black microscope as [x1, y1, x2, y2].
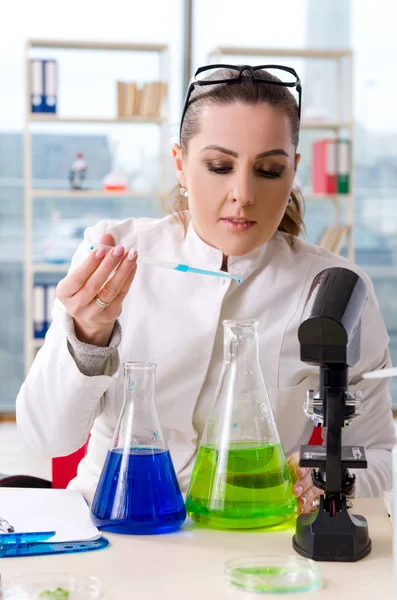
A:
[342, 273, 396, 498]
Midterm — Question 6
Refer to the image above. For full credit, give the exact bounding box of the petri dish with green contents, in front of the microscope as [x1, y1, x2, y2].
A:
[225, 555, 322, 594]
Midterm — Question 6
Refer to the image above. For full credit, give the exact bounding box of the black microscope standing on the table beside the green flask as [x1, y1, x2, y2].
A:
[292, 267, 371, 562]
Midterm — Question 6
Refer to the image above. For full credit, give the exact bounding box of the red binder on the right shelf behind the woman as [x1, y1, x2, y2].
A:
[312, 139, 337, 194]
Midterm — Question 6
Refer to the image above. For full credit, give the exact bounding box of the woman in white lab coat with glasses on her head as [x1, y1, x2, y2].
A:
[17, 67, 395, 512]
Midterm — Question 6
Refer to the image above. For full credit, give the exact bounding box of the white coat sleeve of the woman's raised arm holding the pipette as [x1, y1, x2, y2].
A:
[16, 221, 124, 457]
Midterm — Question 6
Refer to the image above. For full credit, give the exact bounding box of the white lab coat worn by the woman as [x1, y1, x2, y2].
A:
[17, 217, 395, 496]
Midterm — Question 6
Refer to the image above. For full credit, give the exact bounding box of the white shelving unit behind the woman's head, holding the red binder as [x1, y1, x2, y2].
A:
[208, 46, 354, 260]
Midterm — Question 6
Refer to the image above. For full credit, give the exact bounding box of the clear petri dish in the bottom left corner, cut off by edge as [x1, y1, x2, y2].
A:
[0, 573, 103, 600]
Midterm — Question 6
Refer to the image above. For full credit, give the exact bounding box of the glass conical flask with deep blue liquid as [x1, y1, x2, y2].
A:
[91, 362, 186, 534]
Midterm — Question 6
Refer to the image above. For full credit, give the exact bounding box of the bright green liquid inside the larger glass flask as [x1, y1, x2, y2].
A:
[186, 442, 296, 529]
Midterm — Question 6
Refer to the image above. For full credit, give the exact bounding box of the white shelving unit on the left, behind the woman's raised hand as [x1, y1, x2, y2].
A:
[23, 39, 169, 373]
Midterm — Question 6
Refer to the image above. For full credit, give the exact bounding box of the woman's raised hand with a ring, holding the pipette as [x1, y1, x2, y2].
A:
[56, 233, 137, 346]
